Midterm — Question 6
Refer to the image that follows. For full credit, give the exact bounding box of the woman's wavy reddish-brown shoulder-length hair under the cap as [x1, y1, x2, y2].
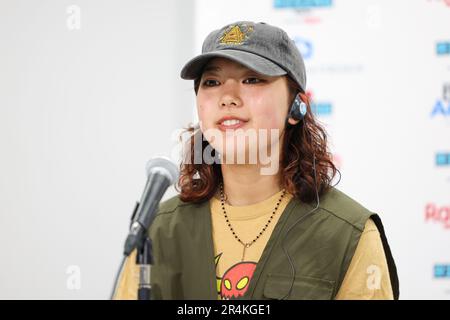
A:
[175, 75, 339, 203]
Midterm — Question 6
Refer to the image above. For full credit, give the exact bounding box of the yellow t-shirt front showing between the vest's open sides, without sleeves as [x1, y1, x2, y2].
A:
[210, 191, 292, 299]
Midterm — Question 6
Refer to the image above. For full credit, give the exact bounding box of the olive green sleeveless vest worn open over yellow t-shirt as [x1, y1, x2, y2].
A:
[149, 188, 399, 300]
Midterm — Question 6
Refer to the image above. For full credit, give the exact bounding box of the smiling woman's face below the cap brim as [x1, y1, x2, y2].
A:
[197, 58, 290, 163]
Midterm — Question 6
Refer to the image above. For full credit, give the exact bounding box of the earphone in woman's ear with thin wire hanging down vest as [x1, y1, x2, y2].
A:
[280, 93, 341, 300]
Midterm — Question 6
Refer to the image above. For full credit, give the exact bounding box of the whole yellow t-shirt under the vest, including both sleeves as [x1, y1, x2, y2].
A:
[114, 191, 393, 300]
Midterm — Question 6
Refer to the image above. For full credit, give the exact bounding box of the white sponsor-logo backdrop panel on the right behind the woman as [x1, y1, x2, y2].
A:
[195, 0, 450, 299]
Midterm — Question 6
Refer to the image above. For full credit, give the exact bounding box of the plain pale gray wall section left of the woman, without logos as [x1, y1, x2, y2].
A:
[0, 0, 193, 299]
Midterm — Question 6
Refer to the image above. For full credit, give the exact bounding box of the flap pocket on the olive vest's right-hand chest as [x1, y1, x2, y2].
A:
[263, 274, 334, 300]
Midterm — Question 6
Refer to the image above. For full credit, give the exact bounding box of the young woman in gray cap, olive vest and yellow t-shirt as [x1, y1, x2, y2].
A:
[115, 21, 399, 299]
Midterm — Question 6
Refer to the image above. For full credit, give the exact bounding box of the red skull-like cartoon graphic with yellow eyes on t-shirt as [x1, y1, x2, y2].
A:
[214, 252, 256, 300]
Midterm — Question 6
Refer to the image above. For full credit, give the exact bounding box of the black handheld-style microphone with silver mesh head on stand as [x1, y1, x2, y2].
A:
[124, 157, 179, 256]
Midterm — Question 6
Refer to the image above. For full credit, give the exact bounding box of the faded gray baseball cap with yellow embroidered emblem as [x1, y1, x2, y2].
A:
[181, 21, 306, 92]
